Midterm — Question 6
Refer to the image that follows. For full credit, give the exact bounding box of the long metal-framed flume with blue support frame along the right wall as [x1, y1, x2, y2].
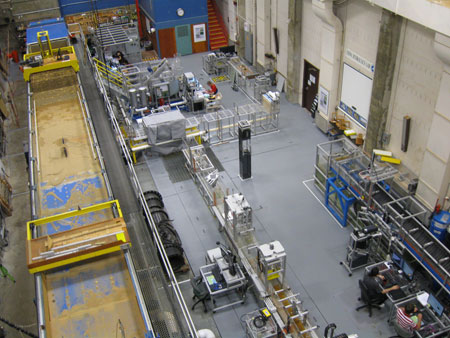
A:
[314, 138, 450, 293]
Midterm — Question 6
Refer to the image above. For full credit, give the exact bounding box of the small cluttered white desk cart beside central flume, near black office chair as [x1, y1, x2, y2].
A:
[200, 258, 247, 312]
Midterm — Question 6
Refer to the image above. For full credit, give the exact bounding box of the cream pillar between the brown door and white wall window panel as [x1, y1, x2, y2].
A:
[312, 0, 342, 120]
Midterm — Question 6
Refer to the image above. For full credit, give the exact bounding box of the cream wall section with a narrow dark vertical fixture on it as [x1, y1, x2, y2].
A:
[387, 21, 443, 175]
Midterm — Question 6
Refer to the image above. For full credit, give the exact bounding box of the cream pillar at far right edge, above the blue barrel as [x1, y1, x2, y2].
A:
[416, 33, 450, 208]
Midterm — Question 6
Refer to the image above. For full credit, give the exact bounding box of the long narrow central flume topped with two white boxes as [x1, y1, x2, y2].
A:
[183, 139, 318, 338]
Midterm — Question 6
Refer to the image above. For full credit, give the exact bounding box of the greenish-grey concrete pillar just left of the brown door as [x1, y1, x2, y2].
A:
[286, 0, 303, 103]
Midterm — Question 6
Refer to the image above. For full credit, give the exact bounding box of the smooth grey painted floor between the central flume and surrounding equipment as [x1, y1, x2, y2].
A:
[142, 55, 400, 338]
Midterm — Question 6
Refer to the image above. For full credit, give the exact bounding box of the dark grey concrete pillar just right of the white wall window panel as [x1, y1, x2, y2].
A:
[364, 10, 403, 153]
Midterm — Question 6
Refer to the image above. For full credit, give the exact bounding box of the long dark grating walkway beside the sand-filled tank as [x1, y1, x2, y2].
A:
[75, 44, 188, 338]
